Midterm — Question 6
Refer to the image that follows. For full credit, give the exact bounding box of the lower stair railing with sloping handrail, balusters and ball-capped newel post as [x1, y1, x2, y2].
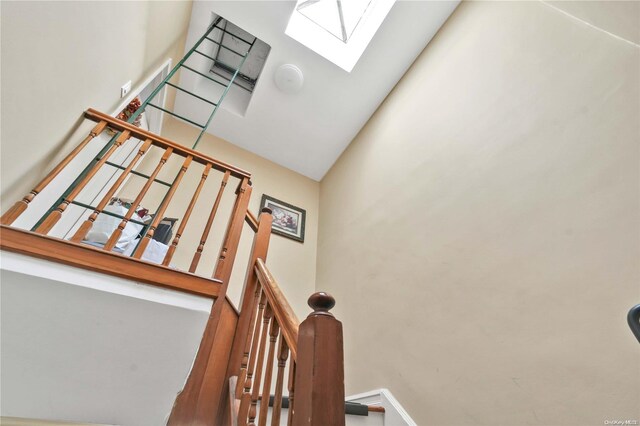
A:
[229, 209, 345, 426]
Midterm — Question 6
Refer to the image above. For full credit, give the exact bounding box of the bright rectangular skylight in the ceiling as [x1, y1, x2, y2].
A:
[285, 0, 395, 72]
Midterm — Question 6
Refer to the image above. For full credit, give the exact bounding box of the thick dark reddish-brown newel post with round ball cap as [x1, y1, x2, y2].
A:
[293, 292, 345, 426]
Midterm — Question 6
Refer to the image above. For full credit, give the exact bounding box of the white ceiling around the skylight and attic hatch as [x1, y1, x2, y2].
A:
[174, 0, 459, 180]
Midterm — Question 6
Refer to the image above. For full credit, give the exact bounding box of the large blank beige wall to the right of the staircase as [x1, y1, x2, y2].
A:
[316, 2, 640, 425]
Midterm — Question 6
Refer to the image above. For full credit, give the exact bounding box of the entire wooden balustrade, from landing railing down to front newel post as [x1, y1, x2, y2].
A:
[0, 115, 345, 426]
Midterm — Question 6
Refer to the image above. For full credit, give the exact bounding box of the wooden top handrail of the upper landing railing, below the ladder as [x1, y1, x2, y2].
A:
[84, 108, 251, 179]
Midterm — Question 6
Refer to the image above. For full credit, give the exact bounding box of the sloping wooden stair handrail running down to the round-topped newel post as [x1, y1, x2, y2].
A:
[255, 259, 300, 361]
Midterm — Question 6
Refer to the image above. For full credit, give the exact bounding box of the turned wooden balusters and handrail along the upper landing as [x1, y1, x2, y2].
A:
[0, 108, 251, 281]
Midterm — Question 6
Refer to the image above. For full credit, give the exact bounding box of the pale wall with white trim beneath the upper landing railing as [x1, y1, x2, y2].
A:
[0, 252, 211, 426]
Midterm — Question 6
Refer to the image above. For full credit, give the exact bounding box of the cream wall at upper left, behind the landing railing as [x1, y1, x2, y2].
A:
[0, 1, 191, 211]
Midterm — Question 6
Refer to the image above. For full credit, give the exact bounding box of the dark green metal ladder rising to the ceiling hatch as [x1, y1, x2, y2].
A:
[31, 17, 257, 231]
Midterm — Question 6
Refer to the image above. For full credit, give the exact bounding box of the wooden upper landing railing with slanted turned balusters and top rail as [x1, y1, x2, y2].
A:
[0, 109, 251, 292]
